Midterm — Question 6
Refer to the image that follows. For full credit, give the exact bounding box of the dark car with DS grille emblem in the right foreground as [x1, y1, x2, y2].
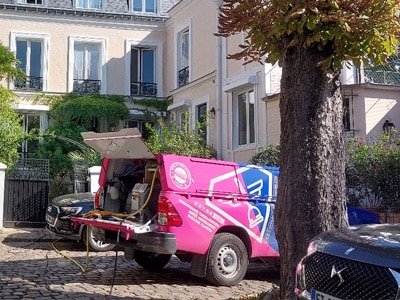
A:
[295, 224, 400, 300]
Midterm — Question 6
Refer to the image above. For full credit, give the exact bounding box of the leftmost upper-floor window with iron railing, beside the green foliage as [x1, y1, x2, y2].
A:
[14, 39, 43, 91]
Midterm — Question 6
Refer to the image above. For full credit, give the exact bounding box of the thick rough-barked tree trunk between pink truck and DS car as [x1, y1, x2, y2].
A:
[275, 38, 348, 300]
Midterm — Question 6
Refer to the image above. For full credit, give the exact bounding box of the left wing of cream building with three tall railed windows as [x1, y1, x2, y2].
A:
[0, 0, 176, 152]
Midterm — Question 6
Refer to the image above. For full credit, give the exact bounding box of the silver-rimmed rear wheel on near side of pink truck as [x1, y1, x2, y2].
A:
[206, 233, 249, 286]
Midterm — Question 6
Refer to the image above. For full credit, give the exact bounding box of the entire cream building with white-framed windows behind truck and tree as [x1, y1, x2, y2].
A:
[0, 0, 400, 162]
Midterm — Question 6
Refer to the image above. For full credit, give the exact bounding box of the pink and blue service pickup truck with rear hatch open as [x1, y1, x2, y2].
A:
[72, 128, 279, 286]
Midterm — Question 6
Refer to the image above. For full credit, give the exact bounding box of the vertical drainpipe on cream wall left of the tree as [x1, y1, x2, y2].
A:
[213, 0, 226, 159]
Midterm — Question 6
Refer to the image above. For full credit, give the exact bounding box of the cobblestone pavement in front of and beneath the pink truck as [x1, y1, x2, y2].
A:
[0, 228, 279, 300]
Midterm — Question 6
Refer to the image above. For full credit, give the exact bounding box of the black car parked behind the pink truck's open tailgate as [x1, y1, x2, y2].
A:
[46, 192, 115, 252]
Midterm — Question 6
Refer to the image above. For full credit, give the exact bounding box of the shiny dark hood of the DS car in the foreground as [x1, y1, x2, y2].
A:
[314, 224, 400, 268]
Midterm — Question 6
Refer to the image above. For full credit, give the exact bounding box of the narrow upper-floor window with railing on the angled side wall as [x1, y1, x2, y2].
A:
[177, 28, 190, 87]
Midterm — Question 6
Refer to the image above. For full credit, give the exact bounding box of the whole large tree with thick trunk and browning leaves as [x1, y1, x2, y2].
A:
[217, 0, 400, 300]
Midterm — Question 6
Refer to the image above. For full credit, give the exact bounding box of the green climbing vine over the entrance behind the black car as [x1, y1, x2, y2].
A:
[35, 94, 129, 197]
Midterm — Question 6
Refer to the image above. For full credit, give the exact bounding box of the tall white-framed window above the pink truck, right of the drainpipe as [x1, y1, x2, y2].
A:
[234, 90, 255, 146]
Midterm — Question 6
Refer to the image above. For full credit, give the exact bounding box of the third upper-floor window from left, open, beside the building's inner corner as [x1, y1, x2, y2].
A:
[130, 48, 157, 97]
